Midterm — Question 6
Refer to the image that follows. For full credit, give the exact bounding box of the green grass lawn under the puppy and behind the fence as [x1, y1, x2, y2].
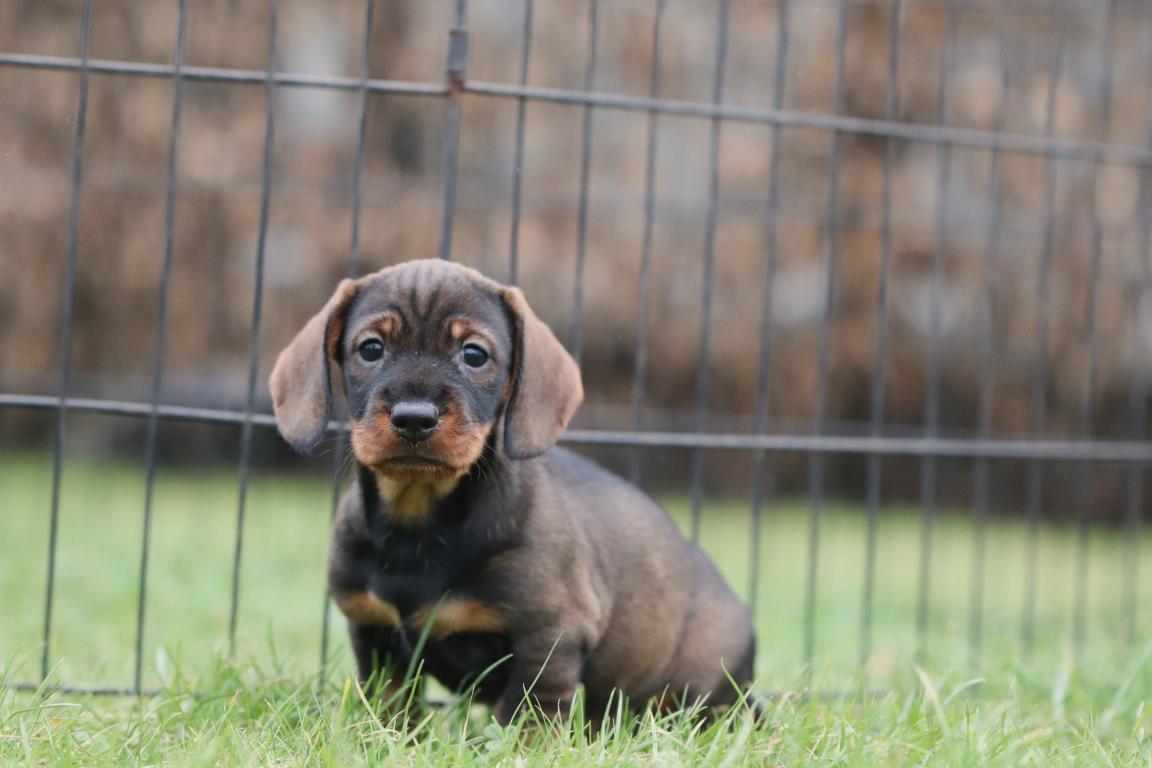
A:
[0, 446, 1152, 766]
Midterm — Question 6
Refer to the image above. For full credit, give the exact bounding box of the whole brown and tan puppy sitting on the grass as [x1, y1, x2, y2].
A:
[271, 260, 755, 722]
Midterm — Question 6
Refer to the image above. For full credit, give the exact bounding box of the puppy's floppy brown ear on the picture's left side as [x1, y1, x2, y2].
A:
[268, 280, 356, 454]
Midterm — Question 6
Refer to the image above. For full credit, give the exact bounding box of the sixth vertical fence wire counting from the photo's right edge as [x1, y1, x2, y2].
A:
[859, 0, 904, 667]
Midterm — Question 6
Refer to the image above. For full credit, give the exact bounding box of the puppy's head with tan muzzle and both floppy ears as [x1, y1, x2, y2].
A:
[270, 260, 583, 481]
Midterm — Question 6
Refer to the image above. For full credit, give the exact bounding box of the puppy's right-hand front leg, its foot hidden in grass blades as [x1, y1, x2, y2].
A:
[494, 631, 584, 725]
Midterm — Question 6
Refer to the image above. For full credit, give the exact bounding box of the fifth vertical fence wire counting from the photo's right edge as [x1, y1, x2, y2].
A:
[916, 0, 956, 655]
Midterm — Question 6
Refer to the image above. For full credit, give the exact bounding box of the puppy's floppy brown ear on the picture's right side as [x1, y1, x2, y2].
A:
[502, 288, 584, 458]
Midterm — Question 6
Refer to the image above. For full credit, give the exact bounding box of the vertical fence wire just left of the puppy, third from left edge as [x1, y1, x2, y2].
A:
[228, 0, 280, 655]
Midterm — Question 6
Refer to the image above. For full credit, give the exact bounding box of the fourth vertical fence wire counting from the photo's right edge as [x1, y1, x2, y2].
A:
[968, 1, 1011, 669]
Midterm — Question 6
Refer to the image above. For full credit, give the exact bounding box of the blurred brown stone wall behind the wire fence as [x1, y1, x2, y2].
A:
[0, 0, 1152, 510]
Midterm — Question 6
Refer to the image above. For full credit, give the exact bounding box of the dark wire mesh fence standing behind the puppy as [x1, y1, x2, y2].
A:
[0, 0, 1152, 698]
